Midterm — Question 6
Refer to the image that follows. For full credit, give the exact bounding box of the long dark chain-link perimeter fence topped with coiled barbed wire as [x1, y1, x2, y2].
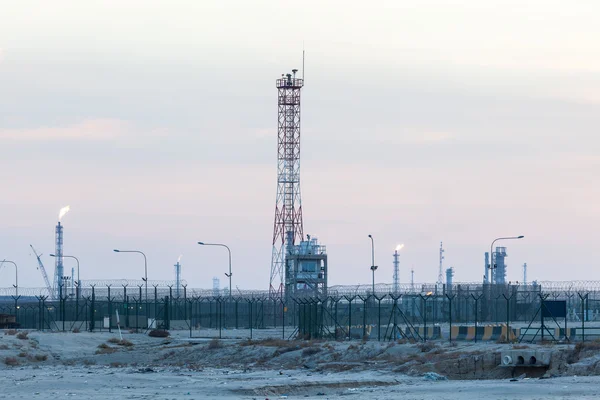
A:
[0, 285, 600, 341]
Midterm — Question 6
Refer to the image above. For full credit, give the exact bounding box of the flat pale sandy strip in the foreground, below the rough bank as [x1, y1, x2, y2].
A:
[0, 367, 600, 400]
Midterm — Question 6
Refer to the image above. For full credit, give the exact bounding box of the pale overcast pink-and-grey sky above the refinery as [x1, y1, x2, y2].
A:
[0, 0, 600, 289]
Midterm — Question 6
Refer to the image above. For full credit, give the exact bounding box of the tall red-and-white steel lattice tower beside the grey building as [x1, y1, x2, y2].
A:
[269, 69, 304, 296]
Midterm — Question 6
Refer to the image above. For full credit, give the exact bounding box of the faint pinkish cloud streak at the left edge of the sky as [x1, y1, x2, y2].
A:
[0, 119, 132, 141]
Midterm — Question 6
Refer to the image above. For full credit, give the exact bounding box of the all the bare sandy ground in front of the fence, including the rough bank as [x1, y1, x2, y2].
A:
[0, 332, 600, 400]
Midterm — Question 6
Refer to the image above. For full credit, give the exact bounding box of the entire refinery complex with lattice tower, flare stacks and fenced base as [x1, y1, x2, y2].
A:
[0, 64, 600, 337]
